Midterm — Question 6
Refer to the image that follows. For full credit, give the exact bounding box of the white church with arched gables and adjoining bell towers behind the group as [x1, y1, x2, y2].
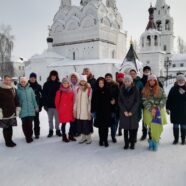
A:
[25, 0, 185, 83]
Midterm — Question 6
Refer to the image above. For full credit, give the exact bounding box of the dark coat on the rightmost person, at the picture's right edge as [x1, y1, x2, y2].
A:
[166, 84, 186, 125]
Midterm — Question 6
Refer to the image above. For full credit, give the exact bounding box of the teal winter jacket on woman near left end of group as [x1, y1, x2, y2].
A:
[17, 84, 38, 118]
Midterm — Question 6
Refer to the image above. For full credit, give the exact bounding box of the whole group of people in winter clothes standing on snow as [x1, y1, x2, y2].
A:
[0, 66, 186, 151]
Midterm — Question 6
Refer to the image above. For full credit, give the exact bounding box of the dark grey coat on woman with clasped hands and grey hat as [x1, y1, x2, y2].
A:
[118, 86, 140, 130]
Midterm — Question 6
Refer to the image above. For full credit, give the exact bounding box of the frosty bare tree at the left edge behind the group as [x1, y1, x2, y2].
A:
[0, 25, 14, 76]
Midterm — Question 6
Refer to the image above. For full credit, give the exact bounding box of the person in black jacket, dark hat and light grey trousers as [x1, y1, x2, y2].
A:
[42, 70, 62, 138]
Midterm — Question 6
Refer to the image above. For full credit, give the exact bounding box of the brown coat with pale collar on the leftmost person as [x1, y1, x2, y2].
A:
[0, 84, 19, 118]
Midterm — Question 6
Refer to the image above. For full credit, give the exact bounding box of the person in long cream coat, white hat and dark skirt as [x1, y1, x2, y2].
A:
[74, 75, 92, 144]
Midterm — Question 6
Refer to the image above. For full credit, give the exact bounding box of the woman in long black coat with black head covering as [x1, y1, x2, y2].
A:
[91, 77, 112, 147]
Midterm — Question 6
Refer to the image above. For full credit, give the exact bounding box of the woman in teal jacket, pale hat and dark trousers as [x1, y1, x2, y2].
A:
[17, 77, 39, 143]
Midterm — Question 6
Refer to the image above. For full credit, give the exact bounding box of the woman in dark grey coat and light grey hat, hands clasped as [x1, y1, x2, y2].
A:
[119, 75, 140, 149]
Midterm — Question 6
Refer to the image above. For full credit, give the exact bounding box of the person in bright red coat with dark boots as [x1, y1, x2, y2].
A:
[55, 78, 76, 143]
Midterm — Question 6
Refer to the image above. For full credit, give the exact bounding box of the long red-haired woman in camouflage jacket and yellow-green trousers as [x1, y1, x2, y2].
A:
[142, 75, 167, 151]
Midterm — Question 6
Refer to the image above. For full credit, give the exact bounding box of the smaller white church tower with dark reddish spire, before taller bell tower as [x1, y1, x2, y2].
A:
[138, 5, 165, 76]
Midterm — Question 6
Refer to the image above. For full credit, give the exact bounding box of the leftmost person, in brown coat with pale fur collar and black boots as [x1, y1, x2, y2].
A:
[0, 75, 20, 147]
